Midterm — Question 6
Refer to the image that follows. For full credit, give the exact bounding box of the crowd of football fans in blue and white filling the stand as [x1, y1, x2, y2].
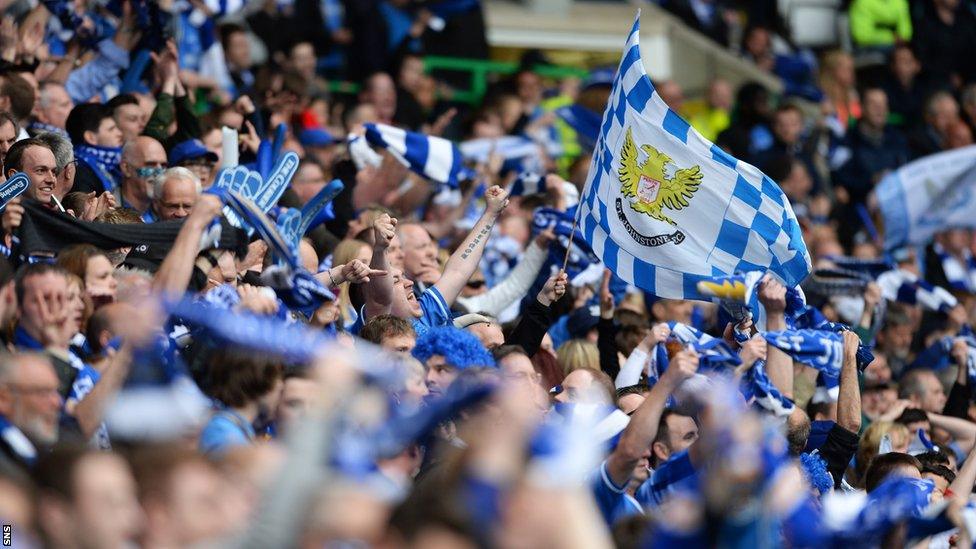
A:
[0, 0, 976, 548]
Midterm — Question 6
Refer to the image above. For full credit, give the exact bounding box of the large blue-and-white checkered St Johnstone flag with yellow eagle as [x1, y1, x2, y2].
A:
[579, 12, 811, 300]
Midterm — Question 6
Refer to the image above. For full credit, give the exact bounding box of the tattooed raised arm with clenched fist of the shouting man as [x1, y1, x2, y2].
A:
[434, 185, 508, 307]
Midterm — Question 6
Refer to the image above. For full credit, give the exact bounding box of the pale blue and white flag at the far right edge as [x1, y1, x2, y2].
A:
[875, 145, 976, 250]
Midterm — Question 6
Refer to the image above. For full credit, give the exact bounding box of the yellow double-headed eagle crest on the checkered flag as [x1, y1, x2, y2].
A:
[617, 128, 702, 225]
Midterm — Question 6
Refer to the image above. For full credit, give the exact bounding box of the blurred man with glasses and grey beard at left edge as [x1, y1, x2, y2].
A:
[0, 353, 61, 476]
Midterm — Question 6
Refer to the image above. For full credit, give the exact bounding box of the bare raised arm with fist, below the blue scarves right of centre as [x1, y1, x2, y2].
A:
[607, 351, 698, 486]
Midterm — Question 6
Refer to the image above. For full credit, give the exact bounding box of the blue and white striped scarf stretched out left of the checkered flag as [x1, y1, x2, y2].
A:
[364, 124, 475, 188]
